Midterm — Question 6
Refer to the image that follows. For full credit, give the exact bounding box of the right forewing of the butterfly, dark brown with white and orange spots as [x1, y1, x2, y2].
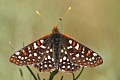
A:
[63, 35, 103, 67]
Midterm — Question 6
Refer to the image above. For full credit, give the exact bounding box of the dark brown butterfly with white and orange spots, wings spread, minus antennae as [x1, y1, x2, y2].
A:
[10, 27, 103, 72]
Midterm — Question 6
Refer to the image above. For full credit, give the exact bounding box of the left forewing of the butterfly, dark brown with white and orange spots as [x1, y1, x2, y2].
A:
[10, 35, 49, 66]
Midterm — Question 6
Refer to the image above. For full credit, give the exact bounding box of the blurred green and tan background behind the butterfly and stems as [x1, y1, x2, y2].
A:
[0, 0, 120, 80]
